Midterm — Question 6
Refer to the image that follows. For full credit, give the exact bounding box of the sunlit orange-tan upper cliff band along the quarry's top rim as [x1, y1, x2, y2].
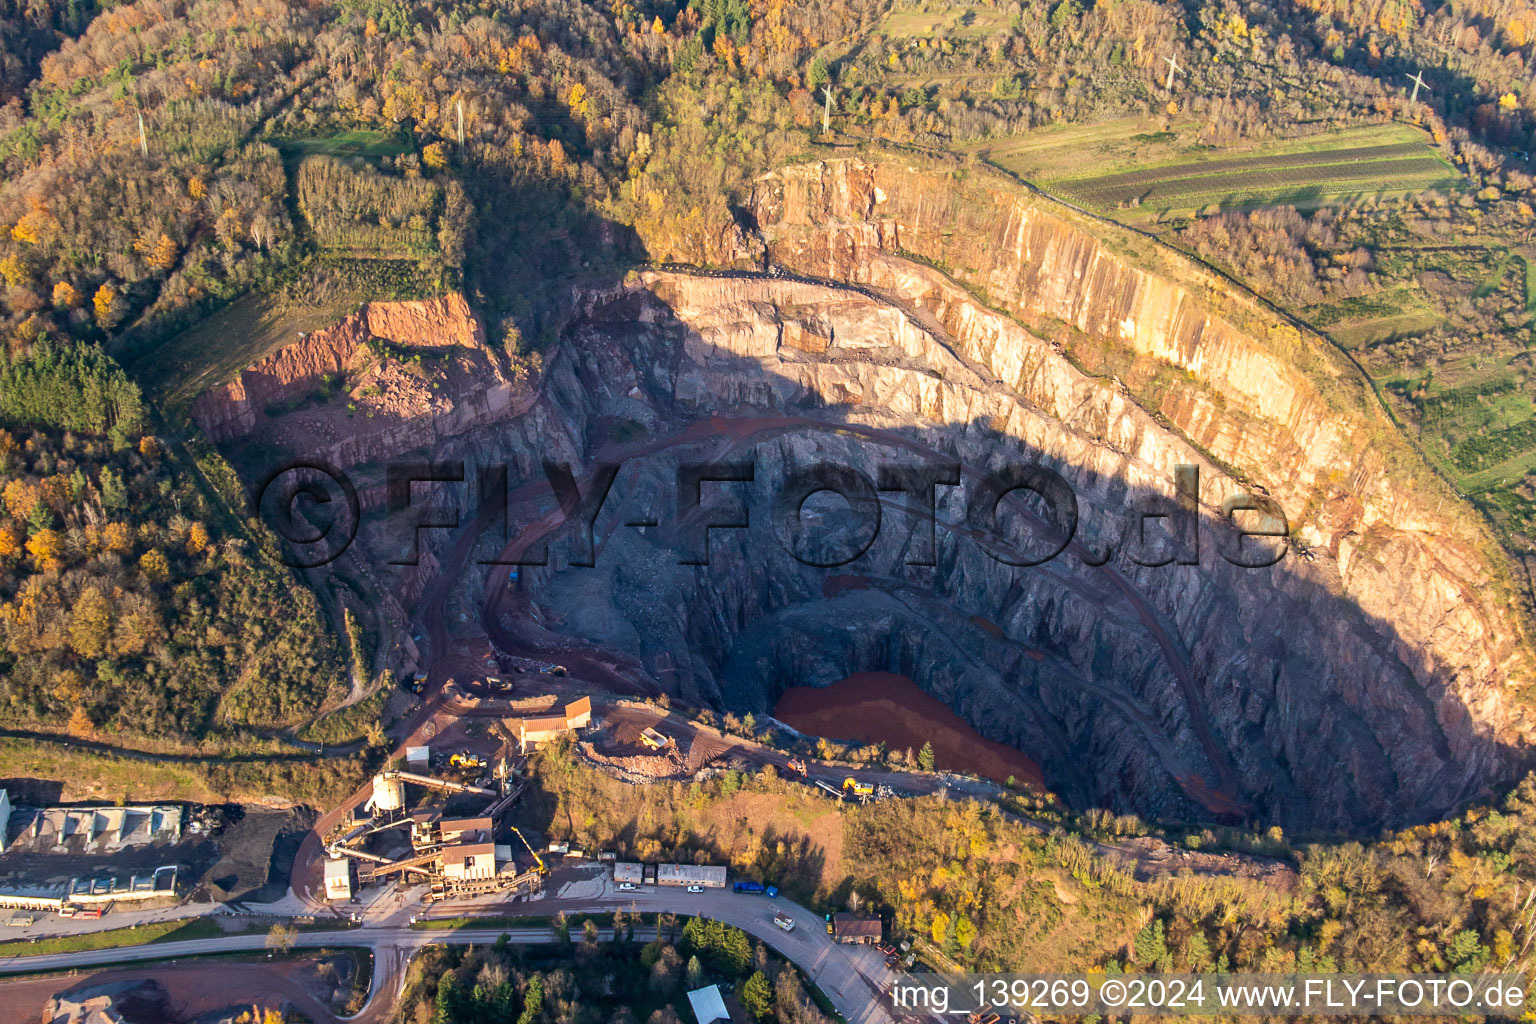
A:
[737, 161, 1533, 798]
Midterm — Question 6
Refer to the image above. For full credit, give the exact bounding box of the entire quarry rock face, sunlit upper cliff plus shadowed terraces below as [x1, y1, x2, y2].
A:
[209, 163, 1528, 831]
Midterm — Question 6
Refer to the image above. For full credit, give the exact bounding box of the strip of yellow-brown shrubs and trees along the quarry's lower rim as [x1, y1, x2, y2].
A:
[530, 749, 1536, 972]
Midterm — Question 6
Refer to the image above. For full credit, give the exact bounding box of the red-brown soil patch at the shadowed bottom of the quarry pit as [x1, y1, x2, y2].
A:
[774, 672, 1044, 791]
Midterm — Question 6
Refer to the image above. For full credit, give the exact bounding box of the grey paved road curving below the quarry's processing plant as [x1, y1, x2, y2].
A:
[0, 880, 891, 1024]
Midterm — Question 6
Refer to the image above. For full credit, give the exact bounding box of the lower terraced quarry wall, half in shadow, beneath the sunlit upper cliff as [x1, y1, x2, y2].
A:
[487, 268, 1519, 829]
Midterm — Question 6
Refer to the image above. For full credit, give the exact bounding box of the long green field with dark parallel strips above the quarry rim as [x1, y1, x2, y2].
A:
[1043, 124, 1462, 218]
